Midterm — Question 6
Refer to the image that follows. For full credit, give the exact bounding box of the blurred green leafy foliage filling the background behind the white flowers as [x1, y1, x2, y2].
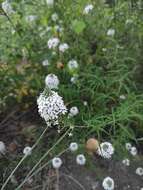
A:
[0, 0, 143, 150]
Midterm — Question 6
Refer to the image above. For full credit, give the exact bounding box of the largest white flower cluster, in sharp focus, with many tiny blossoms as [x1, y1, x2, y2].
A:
[37, 91, 67, 125]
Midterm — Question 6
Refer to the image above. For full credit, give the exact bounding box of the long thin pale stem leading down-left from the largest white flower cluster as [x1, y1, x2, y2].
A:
[1, 126, 48, 190]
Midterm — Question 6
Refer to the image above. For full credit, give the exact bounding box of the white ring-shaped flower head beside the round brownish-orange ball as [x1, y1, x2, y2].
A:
[97, 142, 114, 159]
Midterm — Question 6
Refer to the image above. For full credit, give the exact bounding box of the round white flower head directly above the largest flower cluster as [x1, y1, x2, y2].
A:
[45, 74, 60, 89]
